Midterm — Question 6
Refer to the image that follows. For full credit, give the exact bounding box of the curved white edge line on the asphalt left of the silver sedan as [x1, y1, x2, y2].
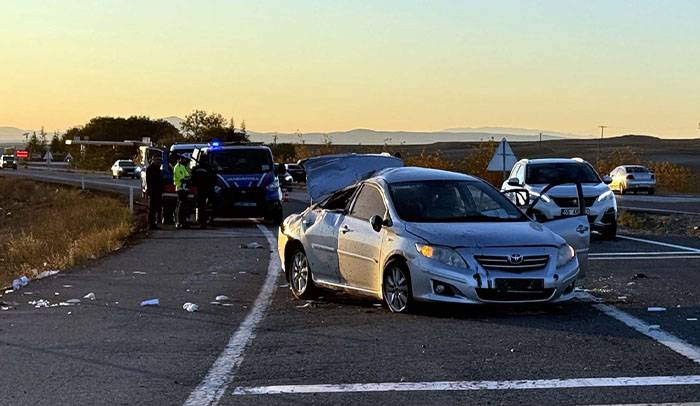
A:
[185, 224, 280, 406]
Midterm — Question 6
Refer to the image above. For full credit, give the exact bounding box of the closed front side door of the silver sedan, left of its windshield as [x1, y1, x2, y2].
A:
[338, 184, 386, 293]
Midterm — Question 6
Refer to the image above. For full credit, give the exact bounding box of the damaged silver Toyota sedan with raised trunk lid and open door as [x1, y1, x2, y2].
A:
[278, 155, 590, 312]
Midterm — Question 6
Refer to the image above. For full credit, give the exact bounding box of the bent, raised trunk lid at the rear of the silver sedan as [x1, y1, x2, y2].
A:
[301, 154, 403, 202]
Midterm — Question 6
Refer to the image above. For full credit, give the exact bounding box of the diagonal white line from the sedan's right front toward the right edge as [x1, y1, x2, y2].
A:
[576, 292, 700, 364]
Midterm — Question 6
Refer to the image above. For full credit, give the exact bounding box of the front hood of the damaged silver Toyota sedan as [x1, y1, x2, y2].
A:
[406, 221, 564, 248]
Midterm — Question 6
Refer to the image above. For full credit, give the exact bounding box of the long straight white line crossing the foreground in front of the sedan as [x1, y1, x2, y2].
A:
[233, 375, 700, 395]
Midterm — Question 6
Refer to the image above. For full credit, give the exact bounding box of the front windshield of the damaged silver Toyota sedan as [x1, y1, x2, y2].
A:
[389, 180, 525, 223]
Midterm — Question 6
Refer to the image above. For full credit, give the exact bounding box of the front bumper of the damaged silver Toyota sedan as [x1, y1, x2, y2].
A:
[408, 249, 579, 304]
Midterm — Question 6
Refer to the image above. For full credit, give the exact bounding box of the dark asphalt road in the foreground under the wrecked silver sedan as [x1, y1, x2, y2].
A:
[0, 167, 700, 405]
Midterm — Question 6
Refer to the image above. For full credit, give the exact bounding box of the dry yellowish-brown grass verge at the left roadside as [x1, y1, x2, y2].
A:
[0, 177, 132, 286]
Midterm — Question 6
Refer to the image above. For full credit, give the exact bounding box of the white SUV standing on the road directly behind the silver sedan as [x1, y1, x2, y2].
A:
[501, 158, 617, 239]
